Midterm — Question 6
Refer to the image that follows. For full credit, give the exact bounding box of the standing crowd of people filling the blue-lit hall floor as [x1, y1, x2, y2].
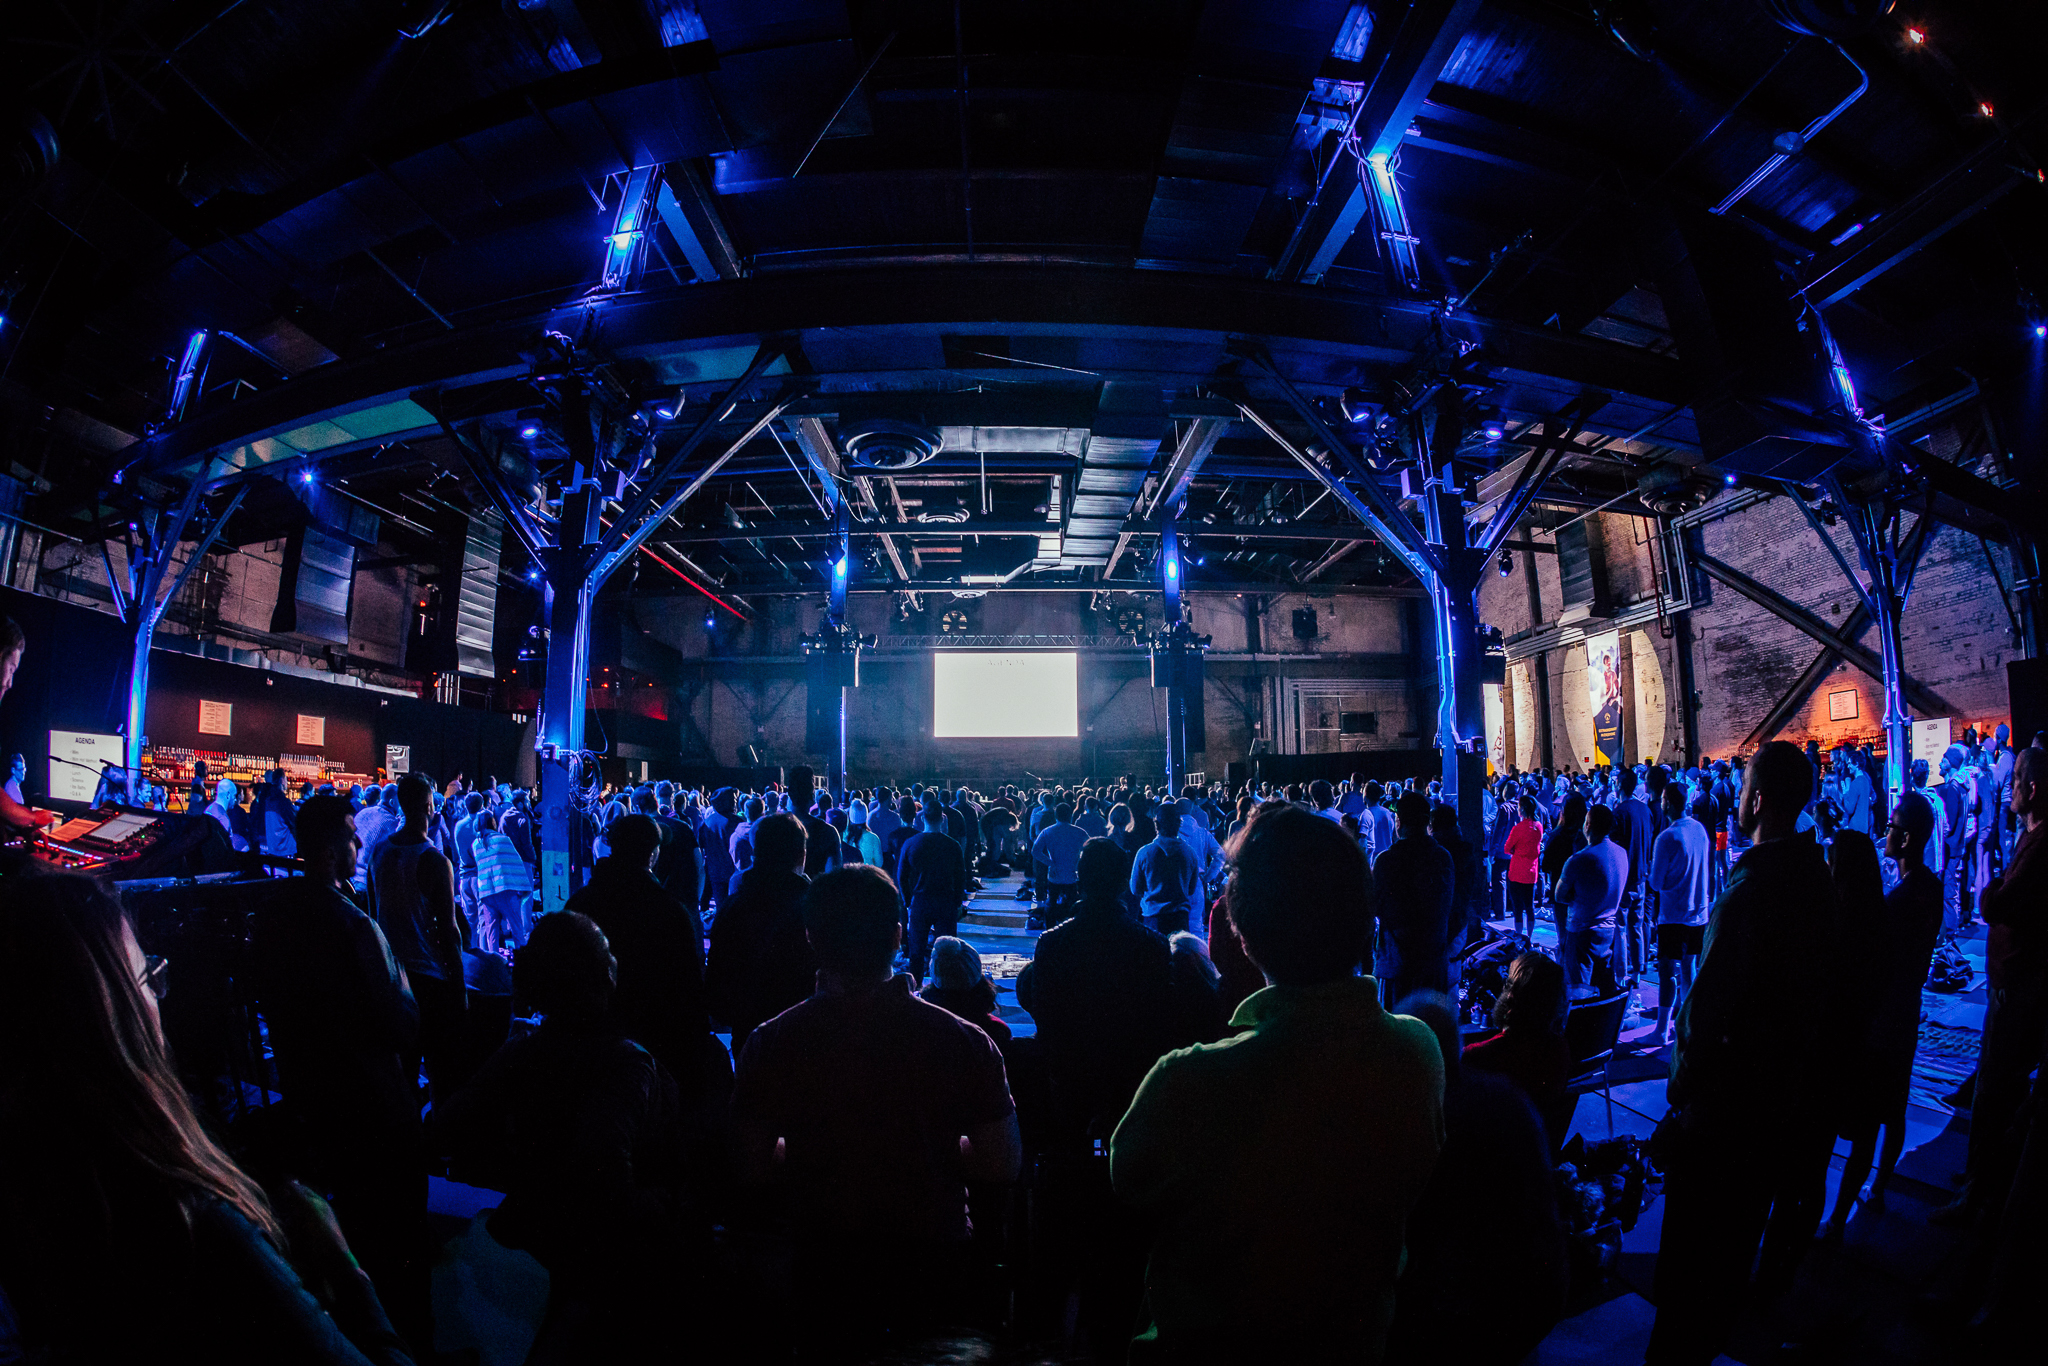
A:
[0, 679, 2048, 1364]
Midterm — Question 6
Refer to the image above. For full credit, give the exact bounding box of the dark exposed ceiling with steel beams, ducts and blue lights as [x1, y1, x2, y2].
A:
[0, 0, 2048, 634]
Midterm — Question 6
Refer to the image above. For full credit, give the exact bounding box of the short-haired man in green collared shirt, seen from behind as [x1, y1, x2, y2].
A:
[1110, 807, 1444, 1364]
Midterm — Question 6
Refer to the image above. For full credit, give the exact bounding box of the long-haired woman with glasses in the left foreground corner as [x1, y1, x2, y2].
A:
[0, 874, 412, 1366]
